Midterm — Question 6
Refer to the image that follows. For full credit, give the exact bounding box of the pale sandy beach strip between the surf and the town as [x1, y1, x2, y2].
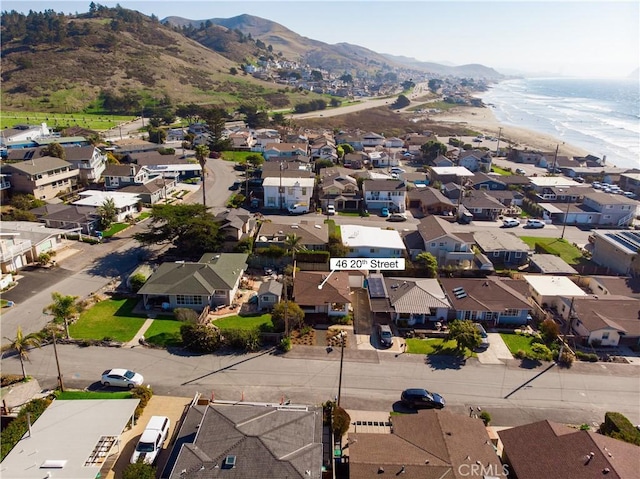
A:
[429, 107, 589, 158]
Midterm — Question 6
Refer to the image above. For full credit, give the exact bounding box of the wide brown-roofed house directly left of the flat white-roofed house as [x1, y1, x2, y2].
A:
[254, 220, 329, 251]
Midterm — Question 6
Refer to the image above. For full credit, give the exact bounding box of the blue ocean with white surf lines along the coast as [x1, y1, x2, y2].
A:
[479, 78, 640, 168]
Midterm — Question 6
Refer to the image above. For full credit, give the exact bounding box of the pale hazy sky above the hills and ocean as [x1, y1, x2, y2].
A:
[1, 0, 640, 77]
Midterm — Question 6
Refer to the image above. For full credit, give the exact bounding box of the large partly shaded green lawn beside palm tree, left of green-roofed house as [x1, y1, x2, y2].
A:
[69, 299, 146, 342]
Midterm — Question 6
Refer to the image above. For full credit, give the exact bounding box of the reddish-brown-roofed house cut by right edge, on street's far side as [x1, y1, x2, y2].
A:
[563, 294, 640, 348]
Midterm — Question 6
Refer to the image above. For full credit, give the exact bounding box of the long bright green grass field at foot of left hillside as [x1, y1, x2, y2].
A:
[0, 110, 135, 130]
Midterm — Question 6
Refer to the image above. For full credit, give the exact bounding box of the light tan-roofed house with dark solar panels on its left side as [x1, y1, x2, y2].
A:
[367, 273, 451, 327]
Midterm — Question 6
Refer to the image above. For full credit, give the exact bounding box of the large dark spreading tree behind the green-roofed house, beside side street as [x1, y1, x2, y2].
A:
[134, 204, 220, 257]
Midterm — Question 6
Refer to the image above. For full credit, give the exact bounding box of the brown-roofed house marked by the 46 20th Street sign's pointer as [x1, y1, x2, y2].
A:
[293, 271, 351, 316]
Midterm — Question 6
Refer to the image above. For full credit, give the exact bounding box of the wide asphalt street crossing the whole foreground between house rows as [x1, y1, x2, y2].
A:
[2, 345, 640, 426]
